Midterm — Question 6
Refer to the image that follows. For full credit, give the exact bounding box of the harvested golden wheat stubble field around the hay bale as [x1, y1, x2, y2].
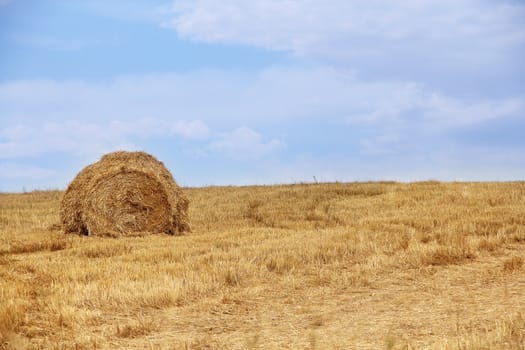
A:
[0, 182, 525, 349]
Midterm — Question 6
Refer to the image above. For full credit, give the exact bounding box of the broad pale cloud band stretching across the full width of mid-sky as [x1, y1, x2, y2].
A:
[0, 66, 525, 130]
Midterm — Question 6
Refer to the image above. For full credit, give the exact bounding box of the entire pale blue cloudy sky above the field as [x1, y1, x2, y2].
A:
[0, 0, 525, 191]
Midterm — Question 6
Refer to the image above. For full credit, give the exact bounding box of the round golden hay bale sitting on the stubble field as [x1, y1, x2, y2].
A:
[60, 151, 190, 236]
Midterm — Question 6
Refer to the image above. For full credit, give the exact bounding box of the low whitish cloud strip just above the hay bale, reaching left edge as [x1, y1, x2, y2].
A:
[0, 118, 284, 160]
